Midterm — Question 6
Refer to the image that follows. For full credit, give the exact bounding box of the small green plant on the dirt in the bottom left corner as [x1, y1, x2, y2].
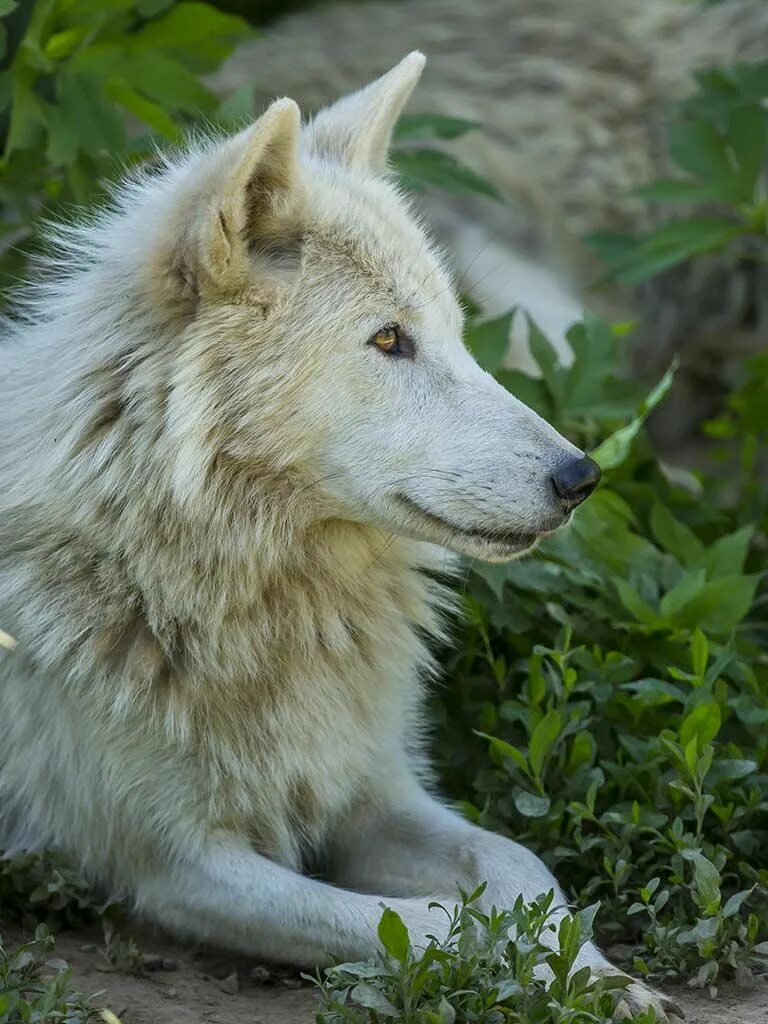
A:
[0, 925, 99, 1024]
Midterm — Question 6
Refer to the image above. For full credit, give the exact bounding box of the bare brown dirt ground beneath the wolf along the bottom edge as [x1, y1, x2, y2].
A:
[4, 929, 768, 1024]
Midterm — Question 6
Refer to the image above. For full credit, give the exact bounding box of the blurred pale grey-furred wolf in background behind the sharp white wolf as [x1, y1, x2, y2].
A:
[215, 0, 768, 452]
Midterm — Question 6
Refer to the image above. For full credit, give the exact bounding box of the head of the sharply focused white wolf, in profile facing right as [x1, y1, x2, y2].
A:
[88, 53, 599, 560]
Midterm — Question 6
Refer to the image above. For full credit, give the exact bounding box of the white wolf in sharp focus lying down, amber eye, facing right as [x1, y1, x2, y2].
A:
[0, 53, 679, 1013]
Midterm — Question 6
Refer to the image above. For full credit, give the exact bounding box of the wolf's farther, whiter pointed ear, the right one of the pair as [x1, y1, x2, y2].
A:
[308, 50, 426, 170]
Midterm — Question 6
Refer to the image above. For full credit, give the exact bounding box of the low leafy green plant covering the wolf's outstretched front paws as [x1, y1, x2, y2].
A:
[315, 887, 655, 1024]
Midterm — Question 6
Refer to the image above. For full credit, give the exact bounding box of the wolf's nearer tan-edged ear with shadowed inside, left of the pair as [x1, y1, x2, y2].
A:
[203, 99, 301, 282]
